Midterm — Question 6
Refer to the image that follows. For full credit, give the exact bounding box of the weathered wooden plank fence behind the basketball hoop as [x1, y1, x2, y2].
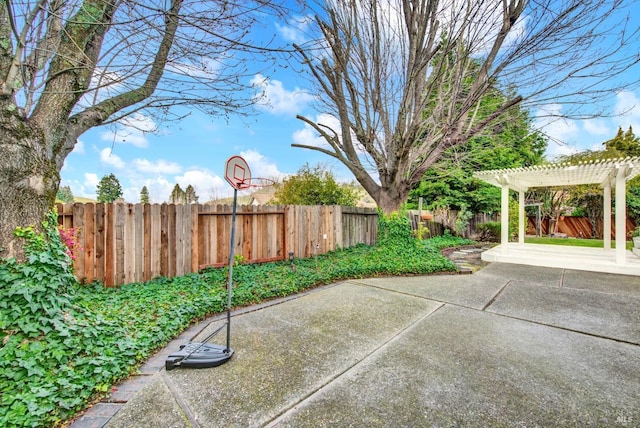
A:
[57, 203, 378, 286]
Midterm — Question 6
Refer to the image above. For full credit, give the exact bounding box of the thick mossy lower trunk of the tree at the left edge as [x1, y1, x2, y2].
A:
[0, 105, 60, 259]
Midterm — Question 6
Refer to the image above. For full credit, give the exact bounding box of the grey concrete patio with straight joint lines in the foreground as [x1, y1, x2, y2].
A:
[73, 263, 640, 428]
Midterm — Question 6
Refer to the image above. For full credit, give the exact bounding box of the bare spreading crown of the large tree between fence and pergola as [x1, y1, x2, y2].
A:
[293, 0, 640, 213]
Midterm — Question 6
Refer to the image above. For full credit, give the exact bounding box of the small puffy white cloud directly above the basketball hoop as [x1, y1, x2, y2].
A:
[250, 74, 314, 114]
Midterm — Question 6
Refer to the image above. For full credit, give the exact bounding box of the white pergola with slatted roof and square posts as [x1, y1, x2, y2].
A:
[474, 157, 640, 274]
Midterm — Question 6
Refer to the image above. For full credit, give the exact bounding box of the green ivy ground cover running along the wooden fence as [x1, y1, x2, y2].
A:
[0, 211, 468, 427]
